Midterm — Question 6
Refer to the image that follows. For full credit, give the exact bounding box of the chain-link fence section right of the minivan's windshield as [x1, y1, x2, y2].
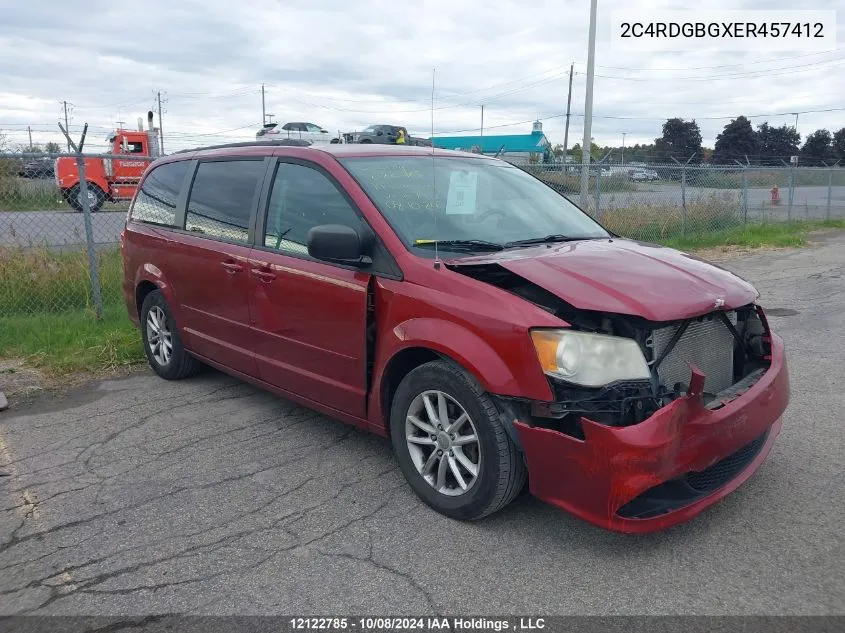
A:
[521, 162, 845, 241]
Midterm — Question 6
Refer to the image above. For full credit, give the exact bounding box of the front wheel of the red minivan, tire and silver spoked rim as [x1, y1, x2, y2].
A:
[390, 360, 527, 521]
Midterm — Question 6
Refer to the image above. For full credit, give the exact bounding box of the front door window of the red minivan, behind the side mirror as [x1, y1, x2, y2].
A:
[264, 163, 361, 255]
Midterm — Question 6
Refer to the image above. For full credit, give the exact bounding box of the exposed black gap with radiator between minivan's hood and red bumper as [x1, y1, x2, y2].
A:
[524, 305, 772, 439]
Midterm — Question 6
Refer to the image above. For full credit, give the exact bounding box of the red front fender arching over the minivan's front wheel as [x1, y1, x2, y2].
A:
[368, 318, 553, 434]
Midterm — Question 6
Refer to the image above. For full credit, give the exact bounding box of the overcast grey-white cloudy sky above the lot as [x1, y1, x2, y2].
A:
[0, 0, 845, 151]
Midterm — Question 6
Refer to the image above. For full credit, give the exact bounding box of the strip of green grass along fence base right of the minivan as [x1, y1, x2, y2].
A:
[660, 220, 845, 250]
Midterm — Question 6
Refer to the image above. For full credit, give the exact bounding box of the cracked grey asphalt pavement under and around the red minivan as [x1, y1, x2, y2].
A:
[0, 233, 845, 615]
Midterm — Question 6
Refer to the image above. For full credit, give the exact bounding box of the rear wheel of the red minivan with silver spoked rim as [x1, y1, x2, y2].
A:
[141, 290, 202, 380]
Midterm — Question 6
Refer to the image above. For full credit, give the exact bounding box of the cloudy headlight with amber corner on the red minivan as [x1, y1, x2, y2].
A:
[531, 330, 650, 387]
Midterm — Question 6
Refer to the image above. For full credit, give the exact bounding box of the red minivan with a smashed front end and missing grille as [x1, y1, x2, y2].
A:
[122, 141, 789, 532]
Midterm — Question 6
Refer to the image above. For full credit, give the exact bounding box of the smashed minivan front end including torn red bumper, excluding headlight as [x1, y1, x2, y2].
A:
[452, 266, 789, 532]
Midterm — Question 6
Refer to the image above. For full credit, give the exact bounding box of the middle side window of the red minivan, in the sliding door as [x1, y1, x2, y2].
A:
[185, 160, 264, 244]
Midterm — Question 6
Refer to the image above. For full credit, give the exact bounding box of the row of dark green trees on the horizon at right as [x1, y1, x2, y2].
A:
[553, 116, 845, 167]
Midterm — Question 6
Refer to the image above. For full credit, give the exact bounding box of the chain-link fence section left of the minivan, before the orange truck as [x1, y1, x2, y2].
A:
[0, 153, 149, 318]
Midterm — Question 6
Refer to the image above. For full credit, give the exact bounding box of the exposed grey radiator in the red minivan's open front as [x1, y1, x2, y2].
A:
[651, 312, 737, 394]
